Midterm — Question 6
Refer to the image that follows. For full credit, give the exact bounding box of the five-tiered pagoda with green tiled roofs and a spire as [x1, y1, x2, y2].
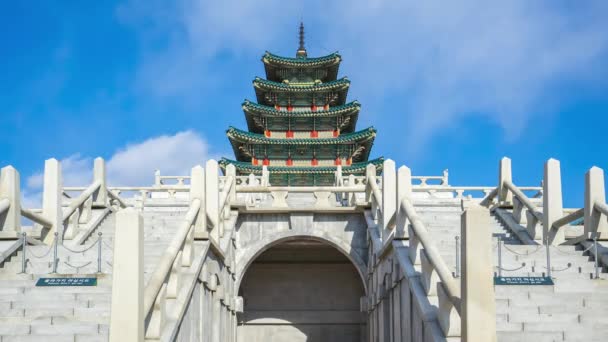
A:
[220, 24, 383, 186]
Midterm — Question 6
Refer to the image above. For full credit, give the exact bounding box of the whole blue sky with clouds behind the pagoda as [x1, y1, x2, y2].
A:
[0, 0, 608, 207]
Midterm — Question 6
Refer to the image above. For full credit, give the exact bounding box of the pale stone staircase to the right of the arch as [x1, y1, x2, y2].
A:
[416, 202, 608, 342]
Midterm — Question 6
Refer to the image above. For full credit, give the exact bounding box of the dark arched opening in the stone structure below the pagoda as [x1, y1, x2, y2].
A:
[238, 239, 366, 342]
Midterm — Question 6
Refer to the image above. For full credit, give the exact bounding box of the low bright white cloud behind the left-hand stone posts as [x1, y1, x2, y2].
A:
[22, 131, 212, 208]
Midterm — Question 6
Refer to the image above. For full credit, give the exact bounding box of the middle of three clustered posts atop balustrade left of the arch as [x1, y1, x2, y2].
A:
[205, 159, 220, 242]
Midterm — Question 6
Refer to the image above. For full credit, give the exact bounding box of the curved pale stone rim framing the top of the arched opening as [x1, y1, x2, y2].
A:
[235, 232, 367, 295]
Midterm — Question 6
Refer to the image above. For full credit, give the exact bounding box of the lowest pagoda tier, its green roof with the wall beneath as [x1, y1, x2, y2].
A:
[219, 158, 384, 186]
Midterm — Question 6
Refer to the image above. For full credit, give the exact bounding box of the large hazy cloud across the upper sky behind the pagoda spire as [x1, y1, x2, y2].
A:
[118, 0, 608, 149]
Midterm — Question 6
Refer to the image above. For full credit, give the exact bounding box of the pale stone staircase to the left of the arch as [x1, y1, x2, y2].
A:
[0, 208, 185, 342]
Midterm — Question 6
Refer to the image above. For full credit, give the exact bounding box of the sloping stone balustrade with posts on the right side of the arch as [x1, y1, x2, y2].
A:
[365, 160, 496, 341]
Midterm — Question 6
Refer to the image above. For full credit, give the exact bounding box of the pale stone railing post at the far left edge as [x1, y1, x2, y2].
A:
[0, 166, 21, 238]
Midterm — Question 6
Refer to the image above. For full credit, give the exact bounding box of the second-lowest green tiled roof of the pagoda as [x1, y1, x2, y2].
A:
[226, 127, 376, 145]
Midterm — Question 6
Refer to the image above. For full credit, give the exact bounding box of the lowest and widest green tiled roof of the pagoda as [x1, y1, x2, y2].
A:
[219, 157, 384, 174]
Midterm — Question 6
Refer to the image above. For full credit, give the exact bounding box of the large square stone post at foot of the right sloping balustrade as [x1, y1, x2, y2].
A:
[460, 205, 496, 342]
